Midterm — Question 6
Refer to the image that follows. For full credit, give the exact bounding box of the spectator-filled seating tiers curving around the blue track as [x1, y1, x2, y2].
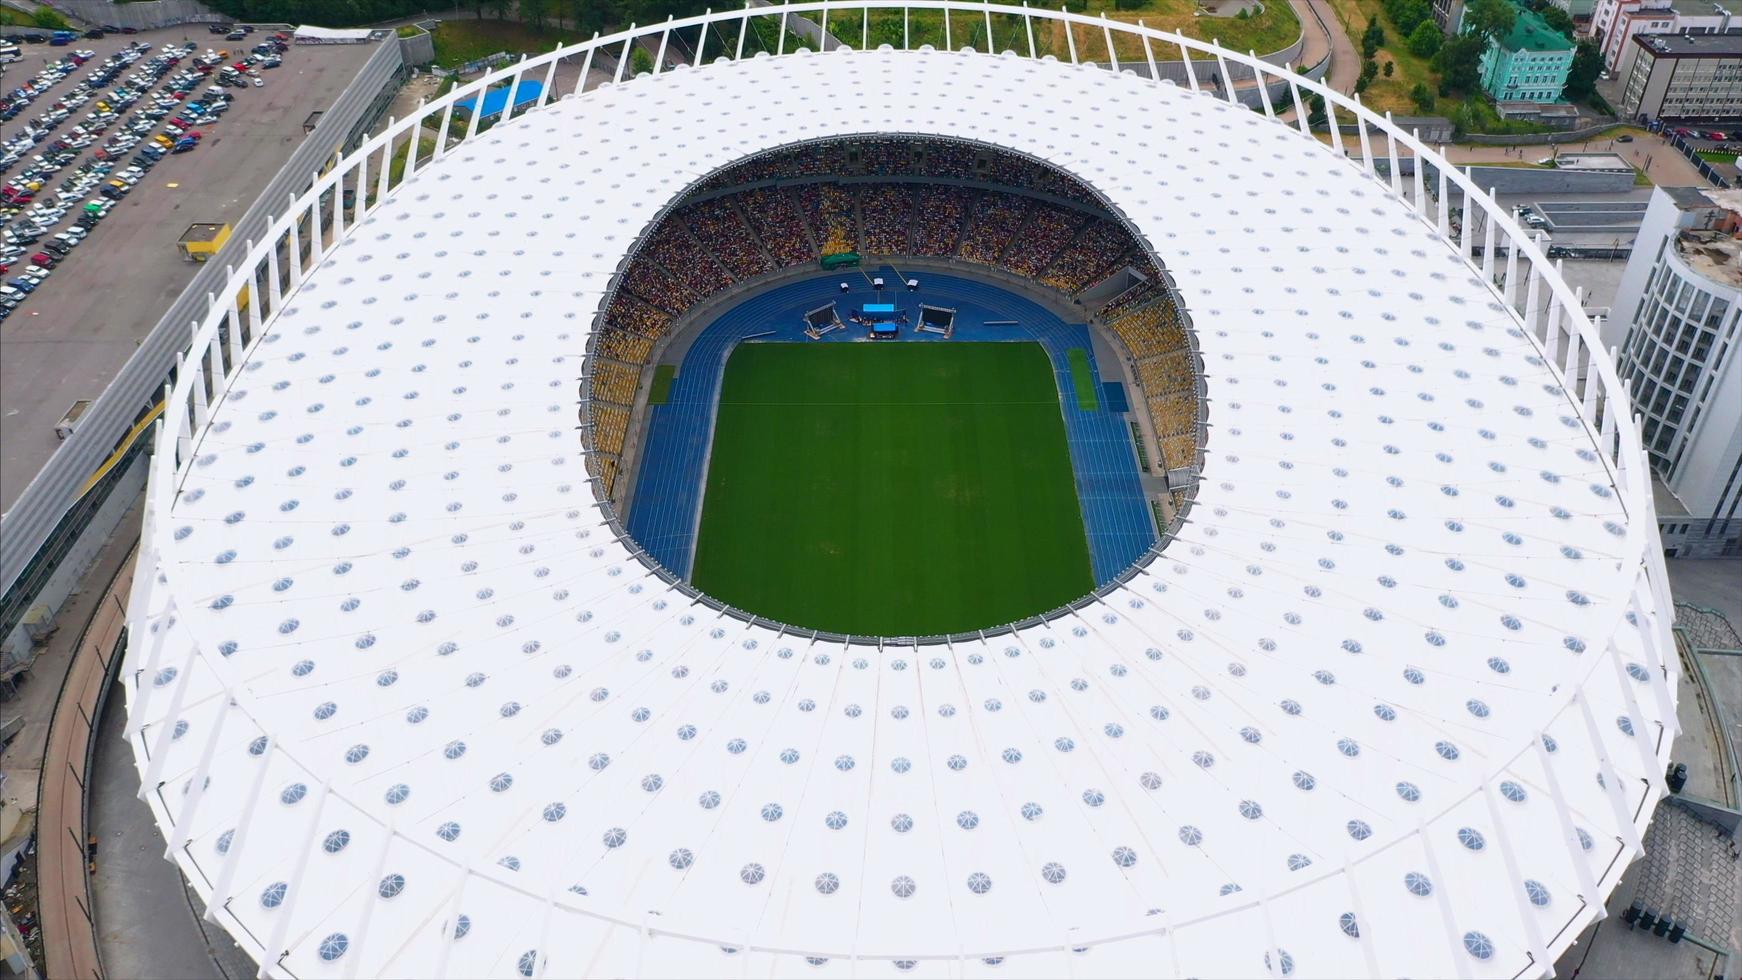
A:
[591, 139, 1198, 484]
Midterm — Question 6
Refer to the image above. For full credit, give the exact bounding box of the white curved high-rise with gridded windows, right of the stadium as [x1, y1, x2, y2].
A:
[1603, 188, 1742, 520]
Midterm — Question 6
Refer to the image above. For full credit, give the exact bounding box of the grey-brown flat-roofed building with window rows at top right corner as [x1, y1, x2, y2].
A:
[1620, 33, 1742, 122]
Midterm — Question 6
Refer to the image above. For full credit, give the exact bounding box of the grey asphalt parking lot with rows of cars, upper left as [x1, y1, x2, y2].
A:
[0, 24, 375, 508]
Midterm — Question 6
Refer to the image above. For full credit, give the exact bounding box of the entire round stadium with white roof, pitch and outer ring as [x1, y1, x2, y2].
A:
[124, 0, 1679, 977]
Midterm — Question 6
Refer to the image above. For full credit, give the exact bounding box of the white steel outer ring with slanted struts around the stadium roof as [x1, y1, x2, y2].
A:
[112, 0, 1681, 977]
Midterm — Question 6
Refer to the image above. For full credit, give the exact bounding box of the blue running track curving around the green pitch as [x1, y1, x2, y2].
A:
[629, 270, 1155, 583]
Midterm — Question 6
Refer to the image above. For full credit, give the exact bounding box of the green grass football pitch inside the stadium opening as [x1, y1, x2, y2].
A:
[693, 343, 1094, 635]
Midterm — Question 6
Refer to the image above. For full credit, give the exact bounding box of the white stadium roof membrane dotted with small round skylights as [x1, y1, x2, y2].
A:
[119, 17, 1674, 977]
